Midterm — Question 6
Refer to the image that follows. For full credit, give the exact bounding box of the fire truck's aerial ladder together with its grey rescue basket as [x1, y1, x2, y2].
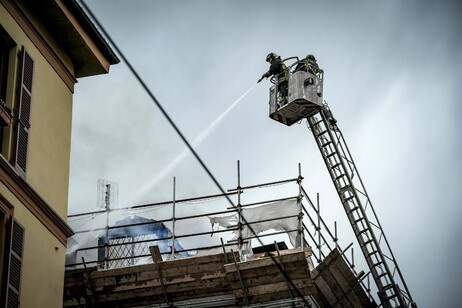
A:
[269, 57, 417, 308]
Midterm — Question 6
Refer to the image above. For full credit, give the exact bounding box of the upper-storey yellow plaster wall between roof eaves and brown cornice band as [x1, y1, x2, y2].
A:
[0, 5, 72, 219]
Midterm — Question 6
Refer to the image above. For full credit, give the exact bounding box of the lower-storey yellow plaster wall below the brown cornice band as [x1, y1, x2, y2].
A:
[0, 182, 66, 308]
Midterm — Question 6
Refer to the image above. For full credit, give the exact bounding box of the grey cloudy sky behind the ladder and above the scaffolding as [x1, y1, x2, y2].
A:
[69, 0, 462, 307]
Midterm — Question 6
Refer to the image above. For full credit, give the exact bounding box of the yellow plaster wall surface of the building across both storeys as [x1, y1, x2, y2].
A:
[0, 4, 72, 308]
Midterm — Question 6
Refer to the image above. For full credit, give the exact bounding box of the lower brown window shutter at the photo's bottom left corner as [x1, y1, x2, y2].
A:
[5, 218, 24, 308]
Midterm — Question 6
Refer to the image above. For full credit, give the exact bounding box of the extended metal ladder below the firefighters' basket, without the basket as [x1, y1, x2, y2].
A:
[307, 105, 417, 307]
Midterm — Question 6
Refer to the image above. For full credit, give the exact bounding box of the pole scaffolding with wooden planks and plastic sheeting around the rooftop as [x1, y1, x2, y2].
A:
[65, 162, 375, 307]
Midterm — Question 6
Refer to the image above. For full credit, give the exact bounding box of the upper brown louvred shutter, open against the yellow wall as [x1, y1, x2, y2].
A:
[14, 47, 34, 177]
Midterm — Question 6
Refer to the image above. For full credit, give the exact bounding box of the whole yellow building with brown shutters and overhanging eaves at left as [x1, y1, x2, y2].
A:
[0, 0, 119, 307]
